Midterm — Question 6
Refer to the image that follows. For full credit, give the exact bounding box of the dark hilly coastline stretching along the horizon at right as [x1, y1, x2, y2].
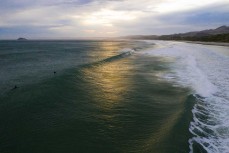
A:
[122, 26, 229, 42]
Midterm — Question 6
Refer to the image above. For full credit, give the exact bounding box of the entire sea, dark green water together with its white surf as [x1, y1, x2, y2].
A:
[0, 40, 229, 153]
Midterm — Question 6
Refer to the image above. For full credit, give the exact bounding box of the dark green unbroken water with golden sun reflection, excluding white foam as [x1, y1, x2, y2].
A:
[0, 41, 195, 153]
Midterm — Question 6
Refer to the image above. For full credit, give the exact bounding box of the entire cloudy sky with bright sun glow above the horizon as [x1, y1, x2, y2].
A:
[0, 0, 229, 39]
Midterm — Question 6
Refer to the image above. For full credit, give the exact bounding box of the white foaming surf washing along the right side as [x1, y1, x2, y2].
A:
[141, 41, 229, 153]
